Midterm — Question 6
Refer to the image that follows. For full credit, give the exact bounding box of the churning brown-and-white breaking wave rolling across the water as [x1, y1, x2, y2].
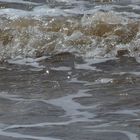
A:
[0, 0, 140, 61]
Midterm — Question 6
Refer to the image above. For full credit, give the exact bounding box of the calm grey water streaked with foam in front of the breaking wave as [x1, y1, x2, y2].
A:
[0, 56, 140, 140]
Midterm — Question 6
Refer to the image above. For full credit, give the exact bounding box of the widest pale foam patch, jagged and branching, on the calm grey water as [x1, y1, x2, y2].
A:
[47, 90, 97, 120]
